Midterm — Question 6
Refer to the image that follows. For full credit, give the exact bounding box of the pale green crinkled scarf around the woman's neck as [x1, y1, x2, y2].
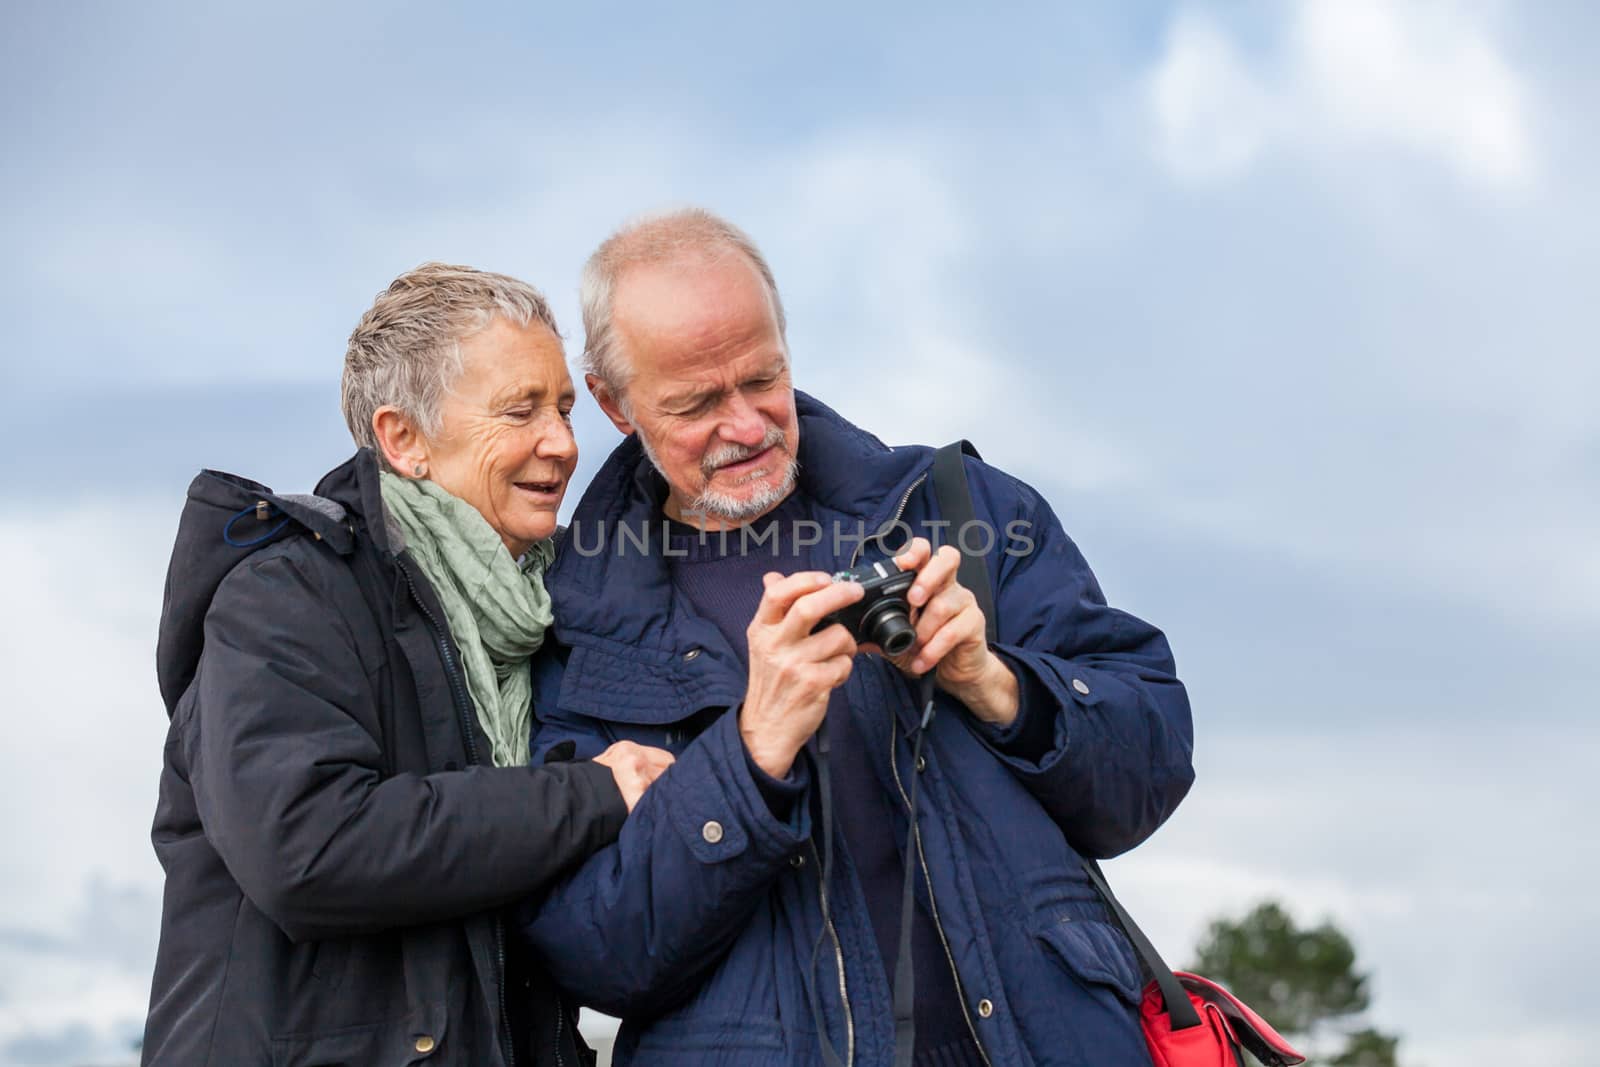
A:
[379, 470, 555, 766]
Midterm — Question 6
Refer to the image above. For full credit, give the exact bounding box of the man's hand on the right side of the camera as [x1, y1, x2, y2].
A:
[893, 537, 1018, 729]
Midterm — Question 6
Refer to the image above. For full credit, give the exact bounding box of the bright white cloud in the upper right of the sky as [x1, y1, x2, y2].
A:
[1146, 0, 1538, 187]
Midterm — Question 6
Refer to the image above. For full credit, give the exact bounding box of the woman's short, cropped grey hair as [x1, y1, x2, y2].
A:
[339, 262, 562, 466]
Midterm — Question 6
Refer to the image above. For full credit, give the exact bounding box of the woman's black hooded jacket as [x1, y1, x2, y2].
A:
[144, 451, 627, 1067]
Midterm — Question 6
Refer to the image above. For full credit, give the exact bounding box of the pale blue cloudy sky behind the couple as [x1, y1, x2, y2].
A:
[0, 0, 1600, 1067]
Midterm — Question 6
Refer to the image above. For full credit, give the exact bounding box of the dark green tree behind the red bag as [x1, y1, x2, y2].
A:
[1189, 901, 1400, 1067]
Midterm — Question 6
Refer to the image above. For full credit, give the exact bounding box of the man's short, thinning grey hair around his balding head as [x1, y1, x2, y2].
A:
[579, 208, 787, 402]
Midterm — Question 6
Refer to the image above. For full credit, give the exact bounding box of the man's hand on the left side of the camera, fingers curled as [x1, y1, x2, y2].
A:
[739, 571, 861, 777]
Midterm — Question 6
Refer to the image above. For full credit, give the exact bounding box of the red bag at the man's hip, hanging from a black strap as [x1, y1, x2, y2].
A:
[1139, 971, 1306, 1067]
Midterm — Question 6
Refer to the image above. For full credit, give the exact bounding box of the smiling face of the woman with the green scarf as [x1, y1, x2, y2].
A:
[422, 317, 578, 557]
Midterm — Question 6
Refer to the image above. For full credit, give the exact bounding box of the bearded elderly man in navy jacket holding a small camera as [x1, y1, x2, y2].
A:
[523, 211, 1194, 1067]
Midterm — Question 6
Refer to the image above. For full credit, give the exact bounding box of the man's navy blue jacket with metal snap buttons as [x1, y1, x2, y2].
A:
[523, 394, 1194, 1067]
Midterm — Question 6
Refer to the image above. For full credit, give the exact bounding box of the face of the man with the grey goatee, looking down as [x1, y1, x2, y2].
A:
[589, 254, 800, 530]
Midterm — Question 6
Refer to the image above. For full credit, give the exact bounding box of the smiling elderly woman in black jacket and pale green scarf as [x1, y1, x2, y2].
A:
[144, 264, 670, 1067]
